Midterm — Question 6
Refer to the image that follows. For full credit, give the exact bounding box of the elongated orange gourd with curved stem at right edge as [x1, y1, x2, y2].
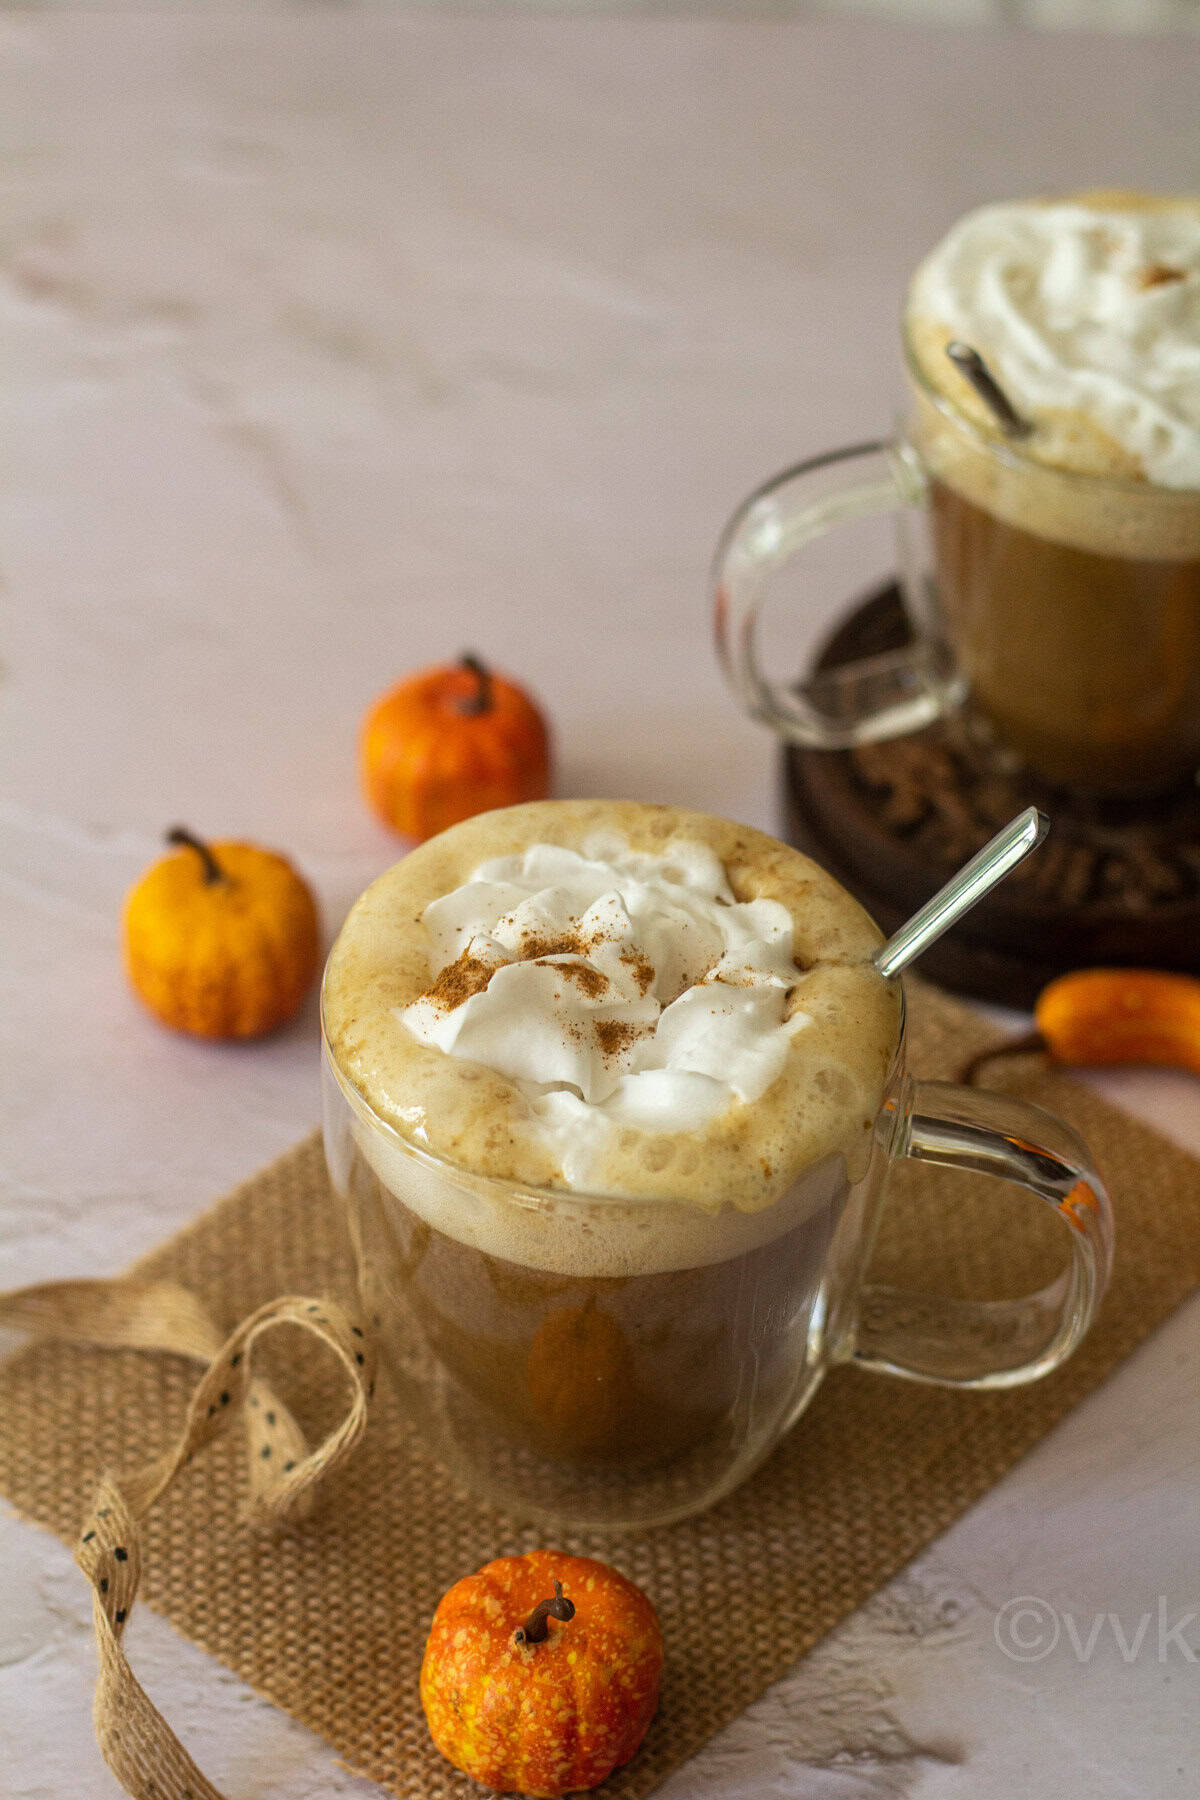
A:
[963, 968, 1200, 1080]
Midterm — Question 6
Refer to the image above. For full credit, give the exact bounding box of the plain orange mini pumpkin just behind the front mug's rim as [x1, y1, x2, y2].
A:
[360, 655, 551, 841]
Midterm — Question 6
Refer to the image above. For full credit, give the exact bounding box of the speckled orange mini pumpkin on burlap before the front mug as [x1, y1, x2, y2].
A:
[421, 1550, 662, 1800]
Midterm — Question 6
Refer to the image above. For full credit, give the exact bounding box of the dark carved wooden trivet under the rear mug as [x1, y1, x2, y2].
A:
[783, 585, 1200, 1006]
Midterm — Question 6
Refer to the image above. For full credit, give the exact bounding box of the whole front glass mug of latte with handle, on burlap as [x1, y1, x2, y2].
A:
[322, 801, 1108, 1528]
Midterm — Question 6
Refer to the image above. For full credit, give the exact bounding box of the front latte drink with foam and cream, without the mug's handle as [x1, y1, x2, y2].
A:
[324, 801, 900, 1467]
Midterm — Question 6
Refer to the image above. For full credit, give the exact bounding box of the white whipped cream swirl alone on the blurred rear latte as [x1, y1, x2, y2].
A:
[909, 202, 1200, 488]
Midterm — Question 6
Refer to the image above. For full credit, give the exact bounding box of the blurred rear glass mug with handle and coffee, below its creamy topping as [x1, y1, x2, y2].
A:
[712, 327, 1200, 796]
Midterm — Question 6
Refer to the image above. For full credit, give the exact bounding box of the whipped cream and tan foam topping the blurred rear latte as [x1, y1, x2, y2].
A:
[905, 194, 1200, 560]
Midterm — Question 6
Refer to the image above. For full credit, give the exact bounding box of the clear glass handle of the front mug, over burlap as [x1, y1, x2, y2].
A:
[847, 1082, 1112, 1388]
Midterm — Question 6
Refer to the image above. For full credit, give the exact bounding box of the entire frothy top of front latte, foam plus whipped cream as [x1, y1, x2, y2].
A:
[324, 801, 898, 1276]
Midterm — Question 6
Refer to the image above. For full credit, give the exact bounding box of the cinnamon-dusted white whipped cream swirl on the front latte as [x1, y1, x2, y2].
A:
[396, 833, 811, 1181]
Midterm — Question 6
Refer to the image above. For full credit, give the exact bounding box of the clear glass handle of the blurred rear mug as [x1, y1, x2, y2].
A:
[712, 443, 964, 751]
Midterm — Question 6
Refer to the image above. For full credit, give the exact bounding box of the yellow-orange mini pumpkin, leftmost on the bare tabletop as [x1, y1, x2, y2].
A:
[124, 826, 320, 1037]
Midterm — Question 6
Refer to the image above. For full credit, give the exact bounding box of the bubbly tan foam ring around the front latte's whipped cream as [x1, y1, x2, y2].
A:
[324, 801, 900, 1267]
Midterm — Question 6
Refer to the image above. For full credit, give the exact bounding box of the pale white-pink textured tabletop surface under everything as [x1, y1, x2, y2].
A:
[0, 11, 1200, 1800]
